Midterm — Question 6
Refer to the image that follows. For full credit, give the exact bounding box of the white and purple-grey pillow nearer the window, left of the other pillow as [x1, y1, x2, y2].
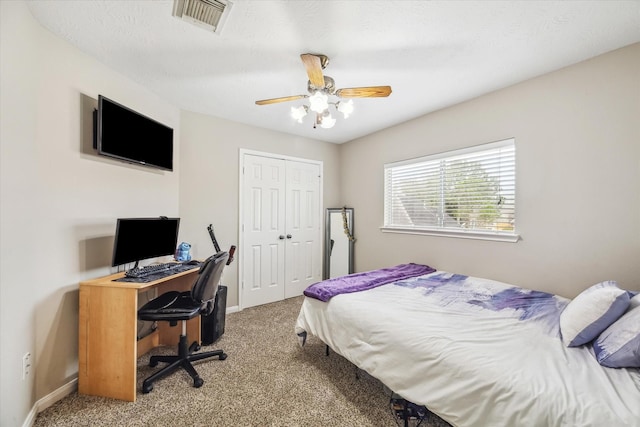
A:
[560, 280, 629, 347]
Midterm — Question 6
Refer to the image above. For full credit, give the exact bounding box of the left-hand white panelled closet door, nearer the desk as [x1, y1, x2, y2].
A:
[241, 154, 286, 307]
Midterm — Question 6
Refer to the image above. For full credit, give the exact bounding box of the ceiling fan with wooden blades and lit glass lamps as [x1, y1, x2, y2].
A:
[256, 53, 391, 128]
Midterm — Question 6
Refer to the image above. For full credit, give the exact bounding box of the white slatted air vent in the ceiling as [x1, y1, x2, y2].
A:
[173, 0, 232, 34]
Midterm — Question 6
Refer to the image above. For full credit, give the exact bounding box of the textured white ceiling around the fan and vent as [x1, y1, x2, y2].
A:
[28, 0, 640, 143]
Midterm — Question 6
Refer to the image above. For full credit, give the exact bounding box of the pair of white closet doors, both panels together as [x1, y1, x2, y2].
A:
[239, 153, 322, 308]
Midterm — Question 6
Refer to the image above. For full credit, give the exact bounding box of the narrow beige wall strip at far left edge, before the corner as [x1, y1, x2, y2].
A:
[0, 2, 39, 426]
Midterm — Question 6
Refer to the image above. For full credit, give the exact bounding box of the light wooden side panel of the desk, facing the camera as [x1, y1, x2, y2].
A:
[78, 285, 138, 402]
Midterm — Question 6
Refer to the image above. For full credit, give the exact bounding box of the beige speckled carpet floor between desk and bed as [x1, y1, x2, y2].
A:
[34, 297, 448, 427]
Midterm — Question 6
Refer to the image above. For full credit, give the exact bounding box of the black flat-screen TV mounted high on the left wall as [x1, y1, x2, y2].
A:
[96, 95, 173, 171]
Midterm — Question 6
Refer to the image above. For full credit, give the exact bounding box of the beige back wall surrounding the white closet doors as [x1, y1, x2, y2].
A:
[180, 112, 340, 307]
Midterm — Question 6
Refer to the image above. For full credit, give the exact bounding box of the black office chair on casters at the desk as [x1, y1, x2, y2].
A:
[138, 252, 229, 393]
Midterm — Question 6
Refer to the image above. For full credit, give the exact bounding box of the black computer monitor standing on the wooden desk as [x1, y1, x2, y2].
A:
[112, 217, 180, 267]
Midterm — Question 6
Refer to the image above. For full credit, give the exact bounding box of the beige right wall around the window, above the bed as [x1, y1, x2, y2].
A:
[341, 44, 640, 297]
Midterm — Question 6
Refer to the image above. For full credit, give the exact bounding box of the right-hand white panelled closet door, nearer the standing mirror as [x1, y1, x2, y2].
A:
[285, 161, 321, 298]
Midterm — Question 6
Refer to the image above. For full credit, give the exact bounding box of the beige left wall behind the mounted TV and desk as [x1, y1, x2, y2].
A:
[0, 1, 171, 426]
